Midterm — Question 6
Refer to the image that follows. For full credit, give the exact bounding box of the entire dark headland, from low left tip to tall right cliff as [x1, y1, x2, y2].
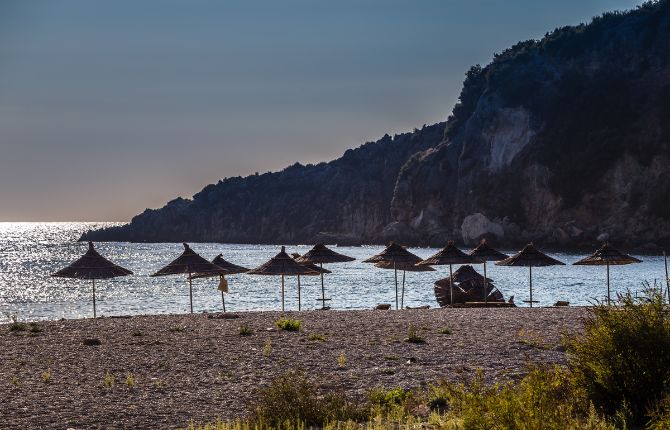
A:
[83, 0, 670, 247]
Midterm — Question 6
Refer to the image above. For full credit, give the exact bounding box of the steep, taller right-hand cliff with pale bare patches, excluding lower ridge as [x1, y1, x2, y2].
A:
[391, 2, 670, 248]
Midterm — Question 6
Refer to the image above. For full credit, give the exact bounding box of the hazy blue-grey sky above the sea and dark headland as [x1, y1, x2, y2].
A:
[0, 0, 652, 221]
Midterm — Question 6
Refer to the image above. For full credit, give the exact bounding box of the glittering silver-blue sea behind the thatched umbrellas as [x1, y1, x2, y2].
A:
[0, 223, 664, 321]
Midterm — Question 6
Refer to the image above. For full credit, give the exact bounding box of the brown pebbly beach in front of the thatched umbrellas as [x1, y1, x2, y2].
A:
[0, 307, 588, 429]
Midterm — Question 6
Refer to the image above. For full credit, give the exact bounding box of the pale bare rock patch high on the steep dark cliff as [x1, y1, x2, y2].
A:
[482, 108, 535, 172]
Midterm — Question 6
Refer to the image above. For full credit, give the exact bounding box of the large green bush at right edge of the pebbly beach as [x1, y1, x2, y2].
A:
[567, 292, 670, 424]
